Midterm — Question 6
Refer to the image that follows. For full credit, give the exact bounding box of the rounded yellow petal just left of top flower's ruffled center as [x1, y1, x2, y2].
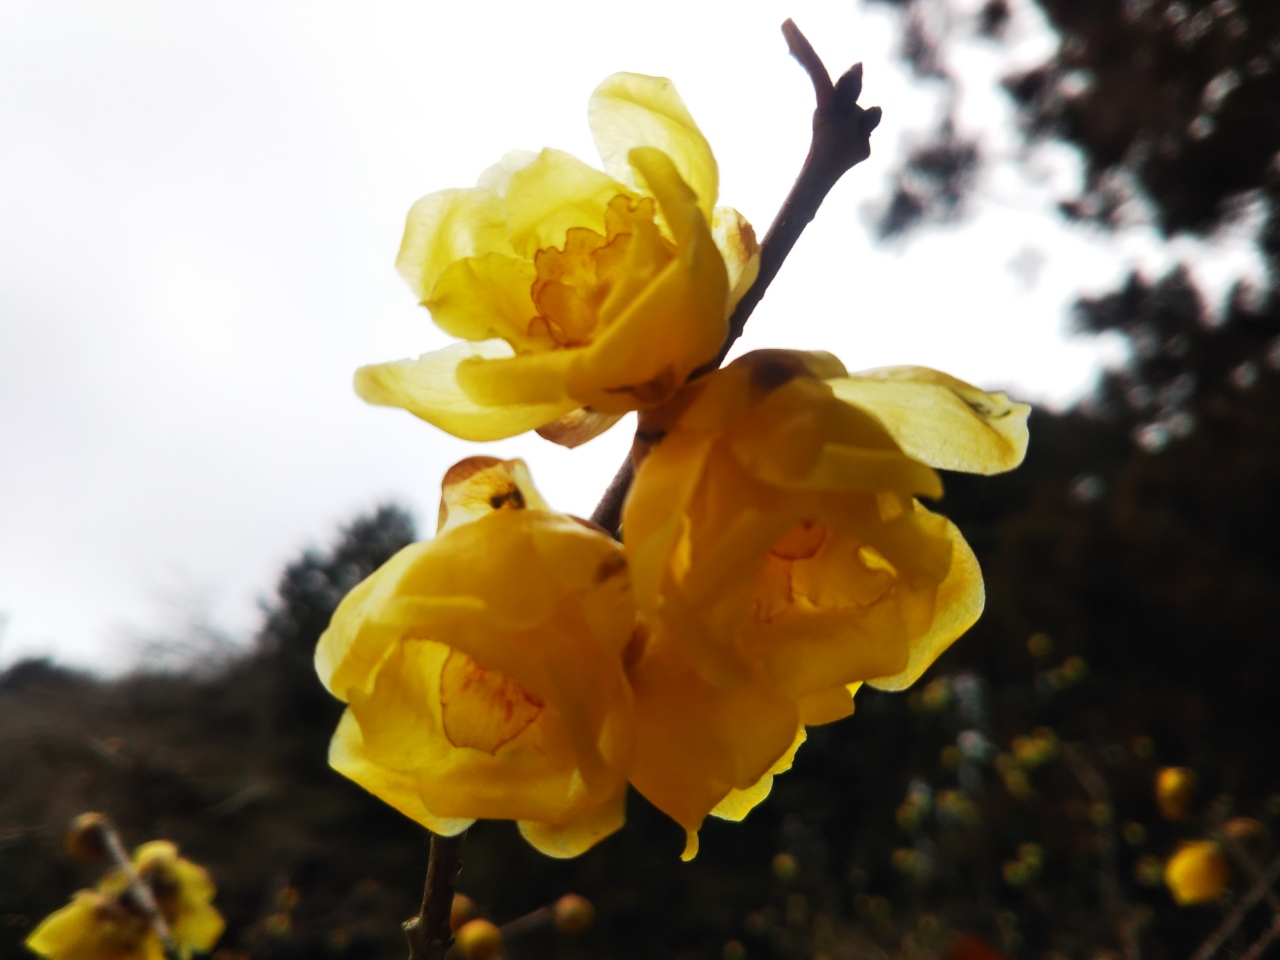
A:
[425, 253, 538, 349]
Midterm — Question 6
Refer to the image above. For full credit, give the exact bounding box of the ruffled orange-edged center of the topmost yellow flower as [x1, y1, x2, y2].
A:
[529, 195, 676, 347]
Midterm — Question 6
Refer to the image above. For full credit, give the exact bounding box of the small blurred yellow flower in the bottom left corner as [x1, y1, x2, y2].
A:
[27, 840, 224, 960]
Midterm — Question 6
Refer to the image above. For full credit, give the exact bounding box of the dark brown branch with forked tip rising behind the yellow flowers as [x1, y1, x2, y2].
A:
[591, 20, 881, 534]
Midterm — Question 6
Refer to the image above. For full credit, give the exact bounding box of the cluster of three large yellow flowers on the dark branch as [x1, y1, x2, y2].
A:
[316, 74, 1028, 856]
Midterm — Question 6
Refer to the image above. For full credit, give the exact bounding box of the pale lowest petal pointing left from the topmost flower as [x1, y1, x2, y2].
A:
[356, 340, 580, 440]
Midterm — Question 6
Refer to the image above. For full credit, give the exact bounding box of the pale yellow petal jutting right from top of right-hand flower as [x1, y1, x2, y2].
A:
[828, 366, 1030, 474]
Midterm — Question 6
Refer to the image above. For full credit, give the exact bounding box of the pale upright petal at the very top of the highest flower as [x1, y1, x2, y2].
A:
[588, 73, 719, 221]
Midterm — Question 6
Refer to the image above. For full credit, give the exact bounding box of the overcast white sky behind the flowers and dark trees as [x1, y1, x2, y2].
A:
[0, 0, 1248, 669]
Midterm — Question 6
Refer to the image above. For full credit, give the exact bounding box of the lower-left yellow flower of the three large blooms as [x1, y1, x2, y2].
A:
[316, 457, 635, 856]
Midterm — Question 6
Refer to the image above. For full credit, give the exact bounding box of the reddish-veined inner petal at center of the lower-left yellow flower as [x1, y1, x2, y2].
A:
[440, 650, 544, 754]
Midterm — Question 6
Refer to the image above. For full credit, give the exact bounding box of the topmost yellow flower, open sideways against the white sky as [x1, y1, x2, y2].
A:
[356, 73, 759, 447]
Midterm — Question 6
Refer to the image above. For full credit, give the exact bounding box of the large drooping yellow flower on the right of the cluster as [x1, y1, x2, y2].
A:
[622, 351, 1029, 831]
